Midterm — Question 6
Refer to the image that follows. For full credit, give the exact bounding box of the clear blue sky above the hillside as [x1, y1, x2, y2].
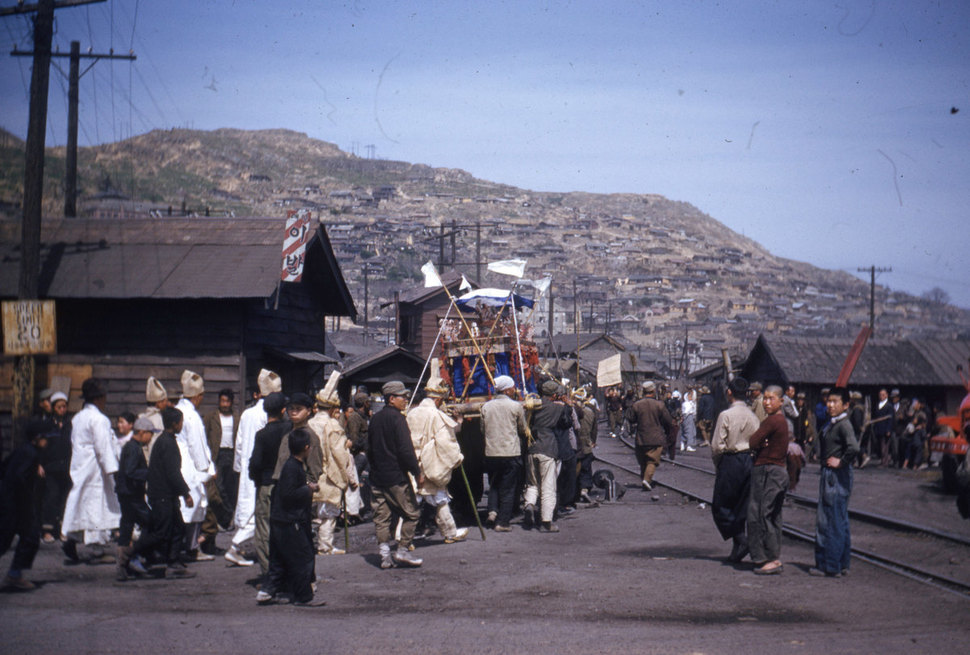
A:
[0, 0, 970, 308]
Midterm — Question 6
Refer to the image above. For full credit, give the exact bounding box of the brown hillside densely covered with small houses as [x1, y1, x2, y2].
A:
[0, 129, 970, 366]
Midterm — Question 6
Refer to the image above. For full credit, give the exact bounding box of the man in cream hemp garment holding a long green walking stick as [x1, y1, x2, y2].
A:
[407, 377, 468, 544]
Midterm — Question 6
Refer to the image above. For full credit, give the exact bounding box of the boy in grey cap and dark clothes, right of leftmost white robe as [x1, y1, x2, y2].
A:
[115, 417, 159, 582]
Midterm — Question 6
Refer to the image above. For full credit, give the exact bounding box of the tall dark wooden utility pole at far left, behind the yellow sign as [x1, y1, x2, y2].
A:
[0, 0, 105, 446]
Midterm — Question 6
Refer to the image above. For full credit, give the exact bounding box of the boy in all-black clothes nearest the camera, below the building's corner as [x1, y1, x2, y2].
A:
[256, 428, 324, 606]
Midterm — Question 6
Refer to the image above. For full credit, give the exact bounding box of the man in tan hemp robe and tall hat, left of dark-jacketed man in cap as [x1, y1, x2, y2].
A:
[307, 371, 360, 555]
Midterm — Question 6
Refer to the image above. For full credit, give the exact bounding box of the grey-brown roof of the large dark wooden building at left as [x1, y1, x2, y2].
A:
[0, 217, 357, 317]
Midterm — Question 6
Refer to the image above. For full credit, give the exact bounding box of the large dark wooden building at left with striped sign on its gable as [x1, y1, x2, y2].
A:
[0, 218, 357, 446]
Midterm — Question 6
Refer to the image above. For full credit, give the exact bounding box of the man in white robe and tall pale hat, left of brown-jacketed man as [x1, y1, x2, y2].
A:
[175, 370, 216, 561]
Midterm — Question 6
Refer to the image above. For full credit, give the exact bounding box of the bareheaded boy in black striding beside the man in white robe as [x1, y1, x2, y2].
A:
[131, 407, 195, 578]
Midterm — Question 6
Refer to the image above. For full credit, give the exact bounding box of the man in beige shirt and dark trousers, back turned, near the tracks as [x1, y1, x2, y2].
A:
[711, 376, 761, 563]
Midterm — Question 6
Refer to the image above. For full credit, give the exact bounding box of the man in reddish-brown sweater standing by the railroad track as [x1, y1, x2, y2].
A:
[747, 385, 789, 575]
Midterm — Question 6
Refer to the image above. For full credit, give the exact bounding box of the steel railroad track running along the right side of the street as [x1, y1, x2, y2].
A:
[596, 436, 970, 599]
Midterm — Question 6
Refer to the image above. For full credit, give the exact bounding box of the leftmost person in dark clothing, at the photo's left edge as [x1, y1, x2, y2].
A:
[0, 418, 57, 591]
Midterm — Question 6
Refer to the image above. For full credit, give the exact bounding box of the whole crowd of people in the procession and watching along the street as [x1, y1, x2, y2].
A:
[0, 370, 952, 604]
